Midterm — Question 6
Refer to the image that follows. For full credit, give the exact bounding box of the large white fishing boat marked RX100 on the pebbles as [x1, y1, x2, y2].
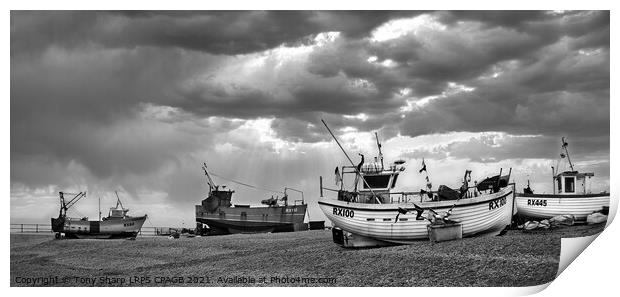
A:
[319, 122, 514, 247]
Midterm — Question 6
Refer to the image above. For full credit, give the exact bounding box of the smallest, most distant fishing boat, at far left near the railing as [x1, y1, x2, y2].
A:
[52, 192, 147, 239]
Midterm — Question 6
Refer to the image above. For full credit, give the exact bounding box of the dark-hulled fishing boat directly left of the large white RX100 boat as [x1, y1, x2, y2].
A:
[196, 164, 308, 235]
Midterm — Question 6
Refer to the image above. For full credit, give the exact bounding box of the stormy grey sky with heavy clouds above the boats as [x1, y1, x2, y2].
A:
[10, 11, 610, 226]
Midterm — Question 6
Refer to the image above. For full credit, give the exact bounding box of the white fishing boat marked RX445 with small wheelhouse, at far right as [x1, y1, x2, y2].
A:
[515, 137, 609, 220]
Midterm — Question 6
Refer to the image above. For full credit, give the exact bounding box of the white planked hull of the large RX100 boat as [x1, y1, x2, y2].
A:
[319, 186, 514, 244]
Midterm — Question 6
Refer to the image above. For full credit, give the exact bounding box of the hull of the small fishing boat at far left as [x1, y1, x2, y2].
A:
[52, 215, 146, 239]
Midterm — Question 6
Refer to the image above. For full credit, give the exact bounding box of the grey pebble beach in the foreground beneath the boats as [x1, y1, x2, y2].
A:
[10, 224, 604, 287]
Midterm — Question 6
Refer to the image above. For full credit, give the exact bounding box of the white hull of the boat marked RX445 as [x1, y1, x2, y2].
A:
[515, 193, 609, 220]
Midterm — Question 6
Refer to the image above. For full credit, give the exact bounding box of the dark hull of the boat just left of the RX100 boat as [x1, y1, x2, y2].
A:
[196, 204, 307, 235]
